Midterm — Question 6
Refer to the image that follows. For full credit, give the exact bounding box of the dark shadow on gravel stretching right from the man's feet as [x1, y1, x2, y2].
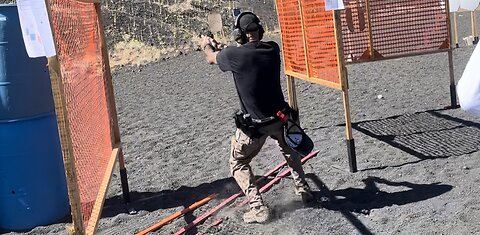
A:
[306, 173, 453, 234]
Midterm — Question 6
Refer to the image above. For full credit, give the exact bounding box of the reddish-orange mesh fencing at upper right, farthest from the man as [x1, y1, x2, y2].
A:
[342, 0, 450, 62]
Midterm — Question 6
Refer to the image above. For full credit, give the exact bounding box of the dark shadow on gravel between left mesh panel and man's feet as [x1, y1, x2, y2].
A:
[102, 177, 240, 220]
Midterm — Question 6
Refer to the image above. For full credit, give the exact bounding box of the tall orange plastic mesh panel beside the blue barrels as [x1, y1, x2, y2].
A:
[50, 0, 112, 226]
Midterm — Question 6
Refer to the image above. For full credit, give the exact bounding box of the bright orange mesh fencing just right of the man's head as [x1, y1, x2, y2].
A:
[277, 0, 341, 89]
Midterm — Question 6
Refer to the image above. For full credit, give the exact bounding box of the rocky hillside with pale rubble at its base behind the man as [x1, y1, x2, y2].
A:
[0, 0, 278, 65]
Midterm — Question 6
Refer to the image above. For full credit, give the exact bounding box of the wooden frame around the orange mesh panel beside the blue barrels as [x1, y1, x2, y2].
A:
[45, 0, 130, 235]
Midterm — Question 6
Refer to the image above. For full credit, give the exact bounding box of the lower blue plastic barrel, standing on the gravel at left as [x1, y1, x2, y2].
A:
[0, 112, 69, 230]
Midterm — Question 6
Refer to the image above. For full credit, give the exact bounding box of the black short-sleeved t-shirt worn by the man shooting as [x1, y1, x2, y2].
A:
[217, 42, 286, 119]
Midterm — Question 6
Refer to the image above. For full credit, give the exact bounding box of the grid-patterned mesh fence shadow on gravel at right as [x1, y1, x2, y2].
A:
[352, 109, 480, 171]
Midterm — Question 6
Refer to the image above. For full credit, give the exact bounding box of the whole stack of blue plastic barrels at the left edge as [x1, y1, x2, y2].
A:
[0, 5, 70, 231]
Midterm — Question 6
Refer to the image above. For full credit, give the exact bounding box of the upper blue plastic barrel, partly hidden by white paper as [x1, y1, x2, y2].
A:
[0, 5, 54, 119]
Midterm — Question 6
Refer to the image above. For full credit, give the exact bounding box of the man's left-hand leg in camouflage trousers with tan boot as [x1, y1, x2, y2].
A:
[230, 129, 268, 223]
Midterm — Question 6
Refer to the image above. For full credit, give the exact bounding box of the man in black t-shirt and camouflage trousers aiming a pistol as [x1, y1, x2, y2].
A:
[201, 12, 313, 223]
